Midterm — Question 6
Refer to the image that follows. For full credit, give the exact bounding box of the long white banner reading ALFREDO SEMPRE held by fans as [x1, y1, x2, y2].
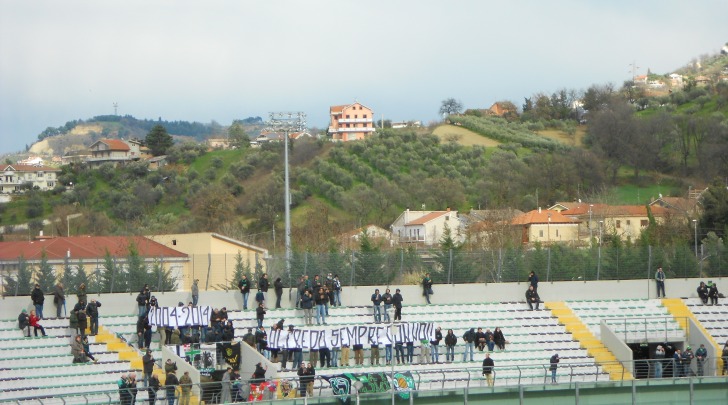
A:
[268, 322, 435, 350]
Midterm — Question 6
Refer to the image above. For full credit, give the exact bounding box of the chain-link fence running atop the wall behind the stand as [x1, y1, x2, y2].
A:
[0, 245, 728, 296]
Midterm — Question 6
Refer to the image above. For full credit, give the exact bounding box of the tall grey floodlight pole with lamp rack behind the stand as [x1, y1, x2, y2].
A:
[269, 112, 306, 283]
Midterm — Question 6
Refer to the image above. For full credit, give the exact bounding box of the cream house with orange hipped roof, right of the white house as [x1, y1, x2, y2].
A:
[511, 208, 581, 244]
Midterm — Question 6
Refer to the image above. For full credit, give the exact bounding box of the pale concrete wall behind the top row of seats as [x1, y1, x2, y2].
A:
[0, 278, 728, 319]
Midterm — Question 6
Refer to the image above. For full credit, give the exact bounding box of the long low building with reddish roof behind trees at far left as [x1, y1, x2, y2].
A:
[0, 235, 189, 289]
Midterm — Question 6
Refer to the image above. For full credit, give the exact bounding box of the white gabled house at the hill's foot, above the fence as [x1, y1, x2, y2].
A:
[390, 208, 463, 246]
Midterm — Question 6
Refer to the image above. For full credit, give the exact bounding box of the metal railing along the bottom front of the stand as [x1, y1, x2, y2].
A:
[0, 359, 728, 405]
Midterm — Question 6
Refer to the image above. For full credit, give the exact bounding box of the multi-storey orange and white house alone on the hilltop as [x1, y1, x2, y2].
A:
[328, 102, 375, 142]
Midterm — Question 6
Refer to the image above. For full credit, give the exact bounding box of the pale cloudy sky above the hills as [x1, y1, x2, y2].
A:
[0, 0, 728, 154]
